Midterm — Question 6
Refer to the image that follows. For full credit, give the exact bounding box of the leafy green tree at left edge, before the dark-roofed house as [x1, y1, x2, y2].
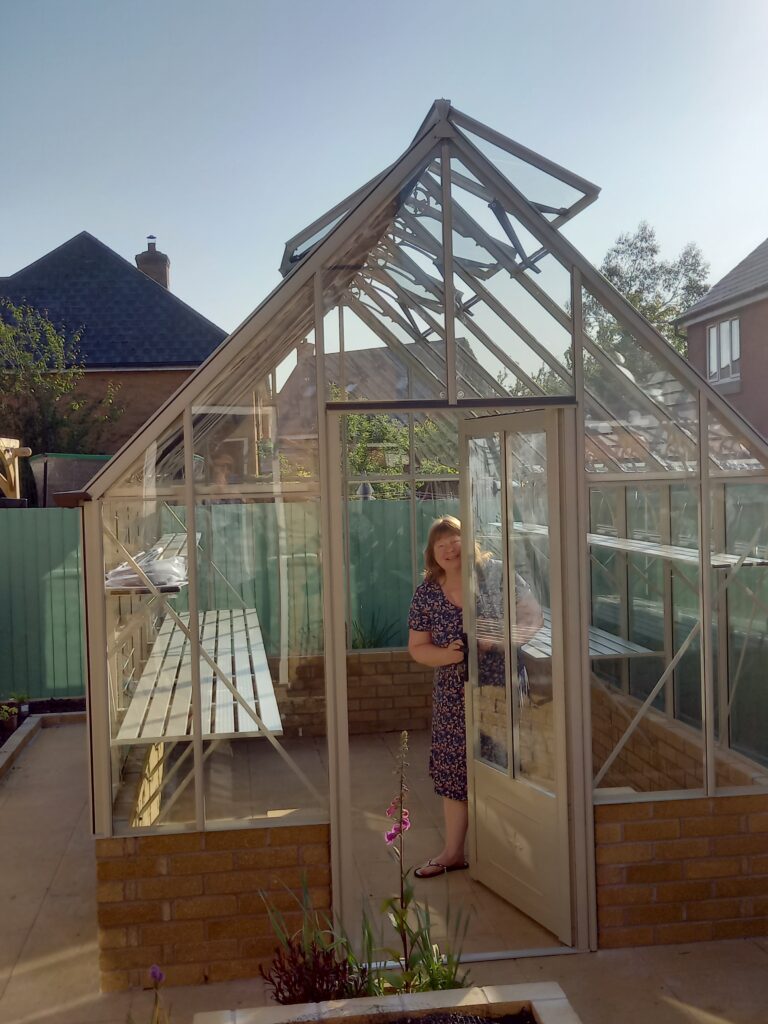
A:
[0, 299, 123, 453]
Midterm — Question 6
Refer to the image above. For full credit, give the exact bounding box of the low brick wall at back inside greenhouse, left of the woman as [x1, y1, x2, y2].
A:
[269, 650, 434, 736]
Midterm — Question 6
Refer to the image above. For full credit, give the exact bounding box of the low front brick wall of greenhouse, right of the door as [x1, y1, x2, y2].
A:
[595, 795, 768, 948]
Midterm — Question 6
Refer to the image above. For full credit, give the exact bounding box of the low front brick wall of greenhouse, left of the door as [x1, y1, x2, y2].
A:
[96, 825, 331, 991]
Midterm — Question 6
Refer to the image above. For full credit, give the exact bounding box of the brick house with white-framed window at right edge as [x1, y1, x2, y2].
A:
[679, 239, 768, 436]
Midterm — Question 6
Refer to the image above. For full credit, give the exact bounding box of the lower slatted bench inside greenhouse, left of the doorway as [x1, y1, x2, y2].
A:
[113, 608, 283, 746]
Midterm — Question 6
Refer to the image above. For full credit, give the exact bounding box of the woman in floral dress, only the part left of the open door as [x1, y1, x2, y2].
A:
[408, 515, 468, 879]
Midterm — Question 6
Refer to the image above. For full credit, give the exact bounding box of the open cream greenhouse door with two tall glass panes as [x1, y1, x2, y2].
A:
[461, 409, 571, 945]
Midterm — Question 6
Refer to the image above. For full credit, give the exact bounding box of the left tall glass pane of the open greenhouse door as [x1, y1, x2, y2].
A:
[468, 433, 512, 772]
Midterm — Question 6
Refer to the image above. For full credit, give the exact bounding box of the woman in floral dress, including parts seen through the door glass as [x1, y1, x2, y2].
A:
[408, 515, 543, 879]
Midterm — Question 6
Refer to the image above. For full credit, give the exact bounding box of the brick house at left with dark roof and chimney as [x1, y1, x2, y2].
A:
[0, 231, 226, 454]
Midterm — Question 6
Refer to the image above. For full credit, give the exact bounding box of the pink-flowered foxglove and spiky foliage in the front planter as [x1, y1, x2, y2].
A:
[259, 732, 468, 1004]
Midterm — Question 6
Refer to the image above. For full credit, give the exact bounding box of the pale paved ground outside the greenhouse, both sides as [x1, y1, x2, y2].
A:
[0, 725, 768, 1024]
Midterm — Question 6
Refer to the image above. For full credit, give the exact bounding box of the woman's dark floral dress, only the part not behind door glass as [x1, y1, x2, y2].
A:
[408, 581, 467, 800]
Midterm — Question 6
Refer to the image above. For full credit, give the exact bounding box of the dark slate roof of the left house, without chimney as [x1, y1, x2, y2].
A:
[0, 231, 226, 370]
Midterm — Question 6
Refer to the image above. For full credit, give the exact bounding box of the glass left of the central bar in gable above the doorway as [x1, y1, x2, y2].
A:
[324, 159, 446, 401]
